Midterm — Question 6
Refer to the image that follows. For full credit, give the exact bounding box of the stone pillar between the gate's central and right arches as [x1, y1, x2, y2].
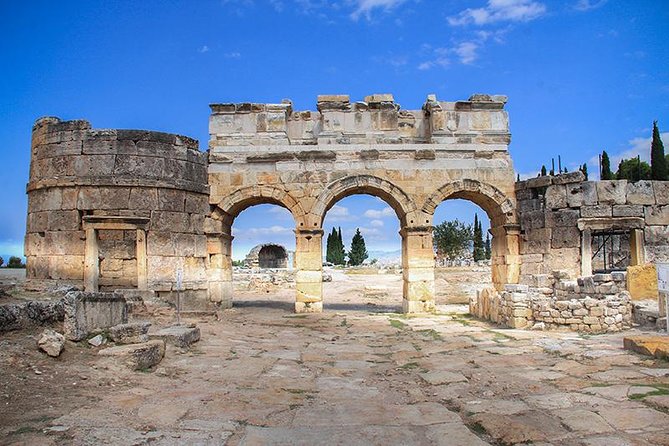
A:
[400, 226, 435, 313]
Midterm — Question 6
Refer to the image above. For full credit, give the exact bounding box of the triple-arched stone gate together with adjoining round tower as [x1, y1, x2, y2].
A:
[25, 94, 520, 312]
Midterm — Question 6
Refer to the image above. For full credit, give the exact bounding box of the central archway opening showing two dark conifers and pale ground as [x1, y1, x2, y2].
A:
[322, 190, 404, 312]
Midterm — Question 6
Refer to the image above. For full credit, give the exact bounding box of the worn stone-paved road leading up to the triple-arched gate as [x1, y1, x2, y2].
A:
[0, 302, 669, 446]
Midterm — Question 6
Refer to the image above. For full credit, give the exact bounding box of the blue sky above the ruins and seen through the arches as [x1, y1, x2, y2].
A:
[0, 0, 669, 255]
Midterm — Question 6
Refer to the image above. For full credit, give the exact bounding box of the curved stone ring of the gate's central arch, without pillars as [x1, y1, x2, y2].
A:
[311, 175, 416, 226]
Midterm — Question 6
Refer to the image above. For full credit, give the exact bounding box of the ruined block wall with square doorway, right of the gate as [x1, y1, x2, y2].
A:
[516, 172, 669, 285]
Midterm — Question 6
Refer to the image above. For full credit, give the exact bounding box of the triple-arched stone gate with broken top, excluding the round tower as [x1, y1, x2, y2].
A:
[205, 94, 519, 313]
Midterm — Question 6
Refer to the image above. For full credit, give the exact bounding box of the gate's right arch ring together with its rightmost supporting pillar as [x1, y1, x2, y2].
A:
[422, 179, 520, 290]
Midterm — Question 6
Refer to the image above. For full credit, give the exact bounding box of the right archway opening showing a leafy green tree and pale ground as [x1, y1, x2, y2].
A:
[433, 198, 494, 305]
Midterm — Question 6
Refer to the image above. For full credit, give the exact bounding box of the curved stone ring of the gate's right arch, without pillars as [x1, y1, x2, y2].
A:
[421, 179, 516, 226]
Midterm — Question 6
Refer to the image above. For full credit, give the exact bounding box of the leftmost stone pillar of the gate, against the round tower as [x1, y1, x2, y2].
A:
[207, 232, 233, 308]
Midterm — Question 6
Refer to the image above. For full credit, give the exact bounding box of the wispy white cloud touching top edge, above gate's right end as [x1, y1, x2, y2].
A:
[448, 0, 546, 26]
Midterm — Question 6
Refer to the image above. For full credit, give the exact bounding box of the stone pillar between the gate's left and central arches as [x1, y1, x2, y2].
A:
[295, 229, 323, 313]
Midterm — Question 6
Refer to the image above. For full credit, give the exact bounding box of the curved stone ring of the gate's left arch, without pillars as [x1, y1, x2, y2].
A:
[212, 186, 305, 225]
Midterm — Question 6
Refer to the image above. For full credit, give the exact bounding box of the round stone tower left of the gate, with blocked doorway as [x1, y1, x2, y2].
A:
[25, 118, 209, 308]
